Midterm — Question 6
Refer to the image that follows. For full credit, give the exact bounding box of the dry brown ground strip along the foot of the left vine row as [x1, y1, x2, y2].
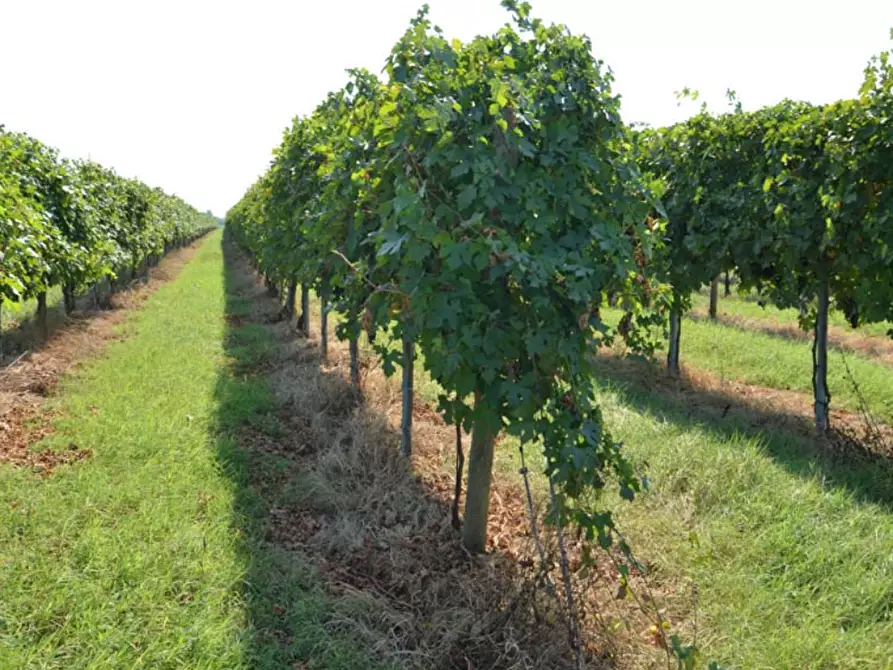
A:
[0, 241, 202, 474]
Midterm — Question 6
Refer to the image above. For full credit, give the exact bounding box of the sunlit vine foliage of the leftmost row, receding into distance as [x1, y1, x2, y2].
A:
[0, 126, 217, 342]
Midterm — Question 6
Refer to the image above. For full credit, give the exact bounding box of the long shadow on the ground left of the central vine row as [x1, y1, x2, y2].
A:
[217, 243, 571, 670]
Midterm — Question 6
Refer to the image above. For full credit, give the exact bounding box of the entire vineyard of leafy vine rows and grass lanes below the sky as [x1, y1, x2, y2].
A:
[0, 0, 893, 670]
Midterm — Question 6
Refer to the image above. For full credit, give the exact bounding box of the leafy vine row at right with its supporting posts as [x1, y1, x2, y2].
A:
[634, 44, 893, 432]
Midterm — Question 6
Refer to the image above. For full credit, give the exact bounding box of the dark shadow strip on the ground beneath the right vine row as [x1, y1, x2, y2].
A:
[596, 356, 893, 510]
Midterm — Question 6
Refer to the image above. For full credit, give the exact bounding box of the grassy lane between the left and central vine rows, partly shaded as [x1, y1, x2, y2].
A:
[0, 233, 376, 670]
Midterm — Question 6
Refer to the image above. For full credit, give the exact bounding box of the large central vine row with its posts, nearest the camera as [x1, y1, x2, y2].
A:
[227, 0, 669, 568]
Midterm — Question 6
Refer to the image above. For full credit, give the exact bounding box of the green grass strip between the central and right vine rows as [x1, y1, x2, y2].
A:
[602, 379, 893, 670]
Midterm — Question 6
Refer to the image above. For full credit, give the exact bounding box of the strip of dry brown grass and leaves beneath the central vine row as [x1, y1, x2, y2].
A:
[231, 255, 695, 670]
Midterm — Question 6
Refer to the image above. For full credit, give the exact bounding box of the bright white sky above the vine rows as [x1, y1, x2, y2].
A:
[0, 0, 893, 216]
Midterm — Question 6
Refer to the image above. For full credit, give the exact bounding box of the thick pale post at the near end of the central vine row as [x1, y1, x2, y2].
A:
[462, 393, 496, 554]
